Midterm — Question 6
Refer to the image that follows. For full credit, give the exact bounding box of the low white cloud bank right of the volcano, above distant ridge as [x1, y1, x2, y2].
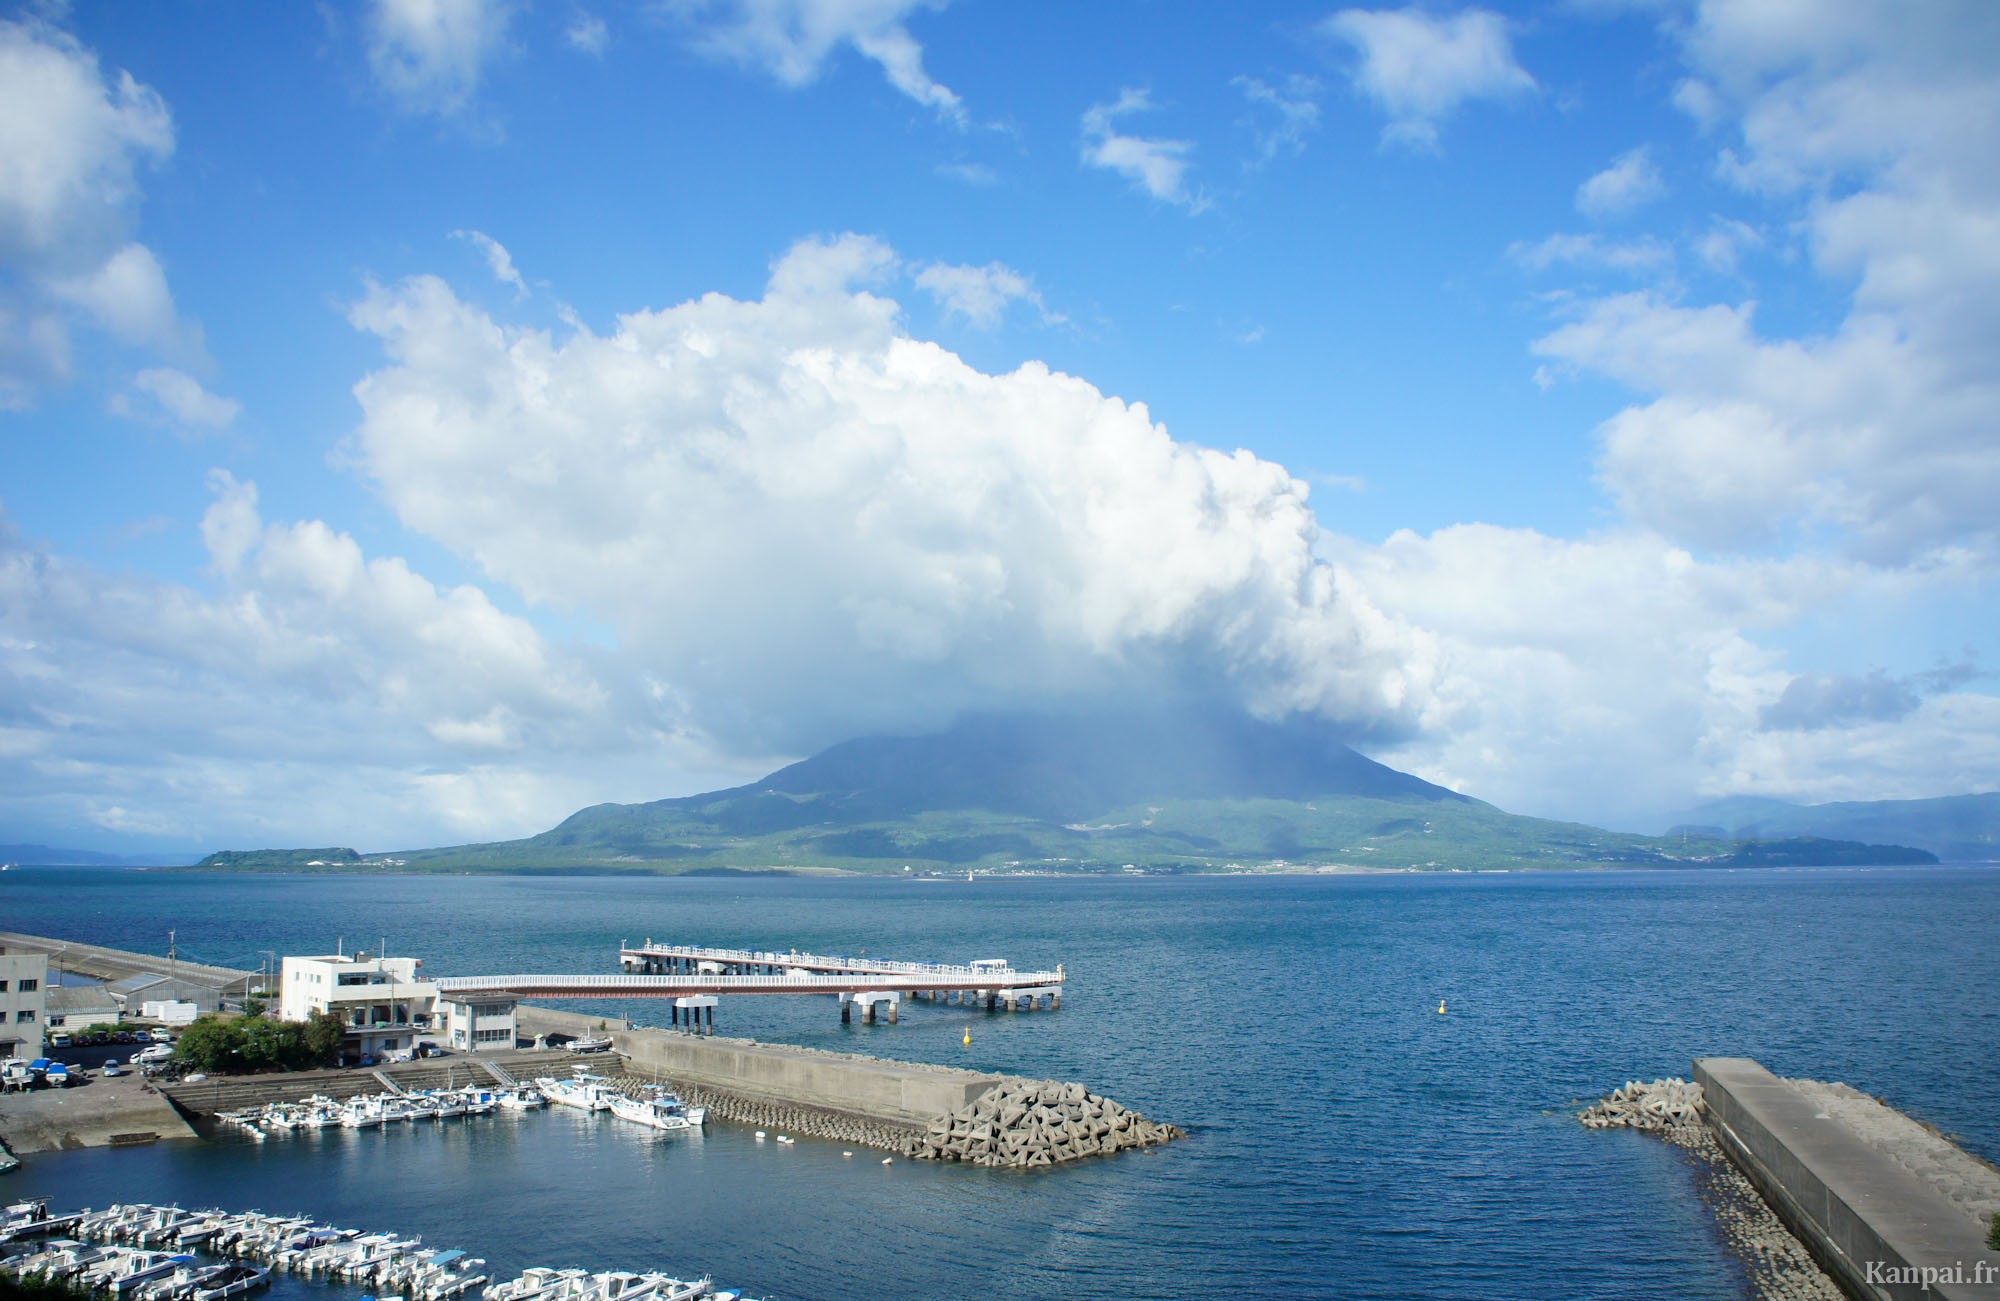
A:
[1332, 524, 2000, 829]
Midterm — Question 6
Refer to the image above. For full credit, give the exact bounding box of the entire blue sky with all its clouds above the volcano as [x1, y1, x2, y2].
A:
[0, 0, 2000, 853]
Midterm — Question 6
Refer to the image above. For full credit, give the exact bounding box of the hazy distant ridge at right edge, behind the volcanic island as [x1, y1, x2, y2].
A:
[1670, 791, 2000, 861]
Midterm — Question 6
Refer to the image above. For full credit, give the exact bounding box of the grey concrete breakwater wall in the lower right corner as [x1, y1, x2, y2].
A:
[1694, 1057, 2000, 1301]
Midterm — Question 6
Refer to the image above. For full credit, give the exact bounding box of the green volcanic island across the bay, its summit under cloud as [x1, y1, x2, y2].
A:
[196, 711, 1938, 875]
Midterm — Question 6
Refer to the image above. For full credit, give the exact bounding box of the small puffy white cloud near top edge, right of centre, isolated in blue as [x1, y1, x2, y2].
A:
[1320, 8, 1534, 148]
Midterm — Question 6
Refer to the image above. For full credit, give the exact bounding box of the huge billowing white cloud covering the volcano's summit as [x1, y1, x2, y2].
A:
[352, 236, 1428, 753]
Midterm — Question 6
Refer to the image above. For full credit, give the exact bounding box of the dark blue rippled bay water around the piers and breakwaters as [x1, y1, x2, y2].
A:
[0, 867, 2000, 1299]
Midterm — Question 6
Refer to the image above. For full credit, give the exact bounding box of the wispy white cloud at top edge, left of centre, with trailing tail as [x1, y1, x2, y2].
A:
[672, 0, 966, 126]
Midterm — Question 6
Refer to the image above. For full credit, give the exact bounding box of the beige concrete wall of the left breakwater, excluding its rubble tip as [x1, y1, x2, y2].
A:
[520, 1005, 1004, 1125]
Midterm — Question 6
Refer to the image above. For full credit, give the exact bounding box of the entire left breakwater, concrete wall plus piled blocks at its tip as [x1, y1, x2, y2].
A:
[520, 1007, 1182, 1167]
